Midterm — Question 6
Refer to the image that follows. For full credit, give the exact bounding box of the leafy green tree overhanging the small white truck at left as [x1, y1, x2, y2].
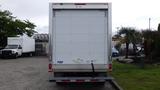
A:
[0, 10, 36, 47]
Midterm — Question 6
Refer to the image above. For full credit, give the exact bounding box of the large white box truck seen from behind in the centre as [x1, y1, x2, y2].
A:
[48, 3, 112, 82]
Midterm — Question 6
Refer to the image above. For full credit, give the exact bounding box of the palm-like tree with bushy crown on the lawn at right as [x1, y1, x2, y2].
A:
[118, 27, 140, 58]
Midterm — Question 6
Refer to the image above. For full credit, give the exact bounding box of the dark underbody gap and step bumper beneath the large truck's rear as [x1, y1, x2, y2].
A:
[49, 72, 112, 82]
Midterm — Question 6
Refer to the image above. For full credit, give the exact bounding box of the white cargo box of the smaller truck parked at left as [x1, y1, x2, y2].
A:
[8, 35, 35, 53]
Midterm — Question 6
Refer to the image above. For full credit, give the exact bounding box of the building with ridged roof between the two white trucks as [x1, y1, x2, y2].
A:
[33, 34, 49, 56]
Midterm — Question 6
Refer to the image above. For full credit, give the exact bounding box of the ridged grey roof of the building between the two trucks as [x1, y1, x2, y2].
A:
[33, 34, 49, 42]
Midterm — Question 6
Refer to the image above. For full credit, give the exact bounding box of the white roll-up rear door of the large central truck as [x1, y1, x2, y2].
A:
[53, 10, 107, 64]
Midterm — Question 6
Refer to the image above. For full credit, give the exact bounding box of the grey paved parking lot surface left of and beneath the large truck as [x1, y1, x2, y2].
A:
[0, 57, 114, 90]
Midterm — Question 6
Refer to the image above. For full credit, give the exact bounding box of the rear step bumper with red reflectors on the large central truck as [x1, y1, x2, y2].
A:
[49, 77, 113, 82]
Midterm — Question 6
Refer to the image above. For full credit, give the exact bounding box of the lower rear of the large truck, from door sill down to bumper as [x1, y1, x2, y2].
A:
[49, 64, 112, 82]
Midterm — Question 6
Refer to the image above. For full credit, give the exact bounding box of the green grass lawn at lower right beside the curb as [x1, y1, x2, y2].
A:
[111, 61, 160, 90]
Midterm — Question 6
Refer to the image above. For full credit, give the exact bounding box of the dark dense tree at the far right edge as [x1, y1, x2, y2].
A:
[142, 30, 160, 63]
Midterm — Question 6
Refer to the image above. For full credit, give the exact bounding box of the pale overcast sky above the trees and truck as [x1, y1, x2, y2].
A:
[0, 0, 160, 33]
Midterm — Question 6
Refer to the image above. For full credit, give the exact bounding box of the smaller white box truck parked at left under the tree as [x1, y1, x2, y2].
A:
[0, 35, 35, 58]
